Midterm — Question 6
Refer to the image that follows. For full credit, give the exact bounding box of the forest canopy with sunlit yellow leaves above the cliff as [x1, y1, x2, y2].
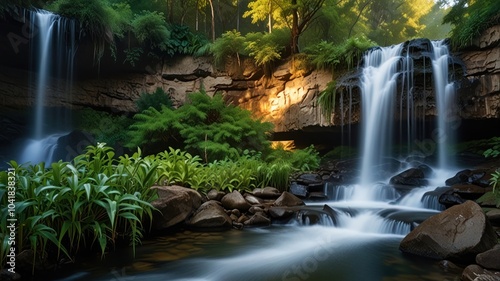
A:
[0, 0, 500, 62]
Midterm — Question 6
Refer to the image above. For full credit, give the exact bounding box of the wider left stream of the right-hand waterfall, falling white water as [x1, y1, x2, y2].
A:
[361, 44, 404, 185]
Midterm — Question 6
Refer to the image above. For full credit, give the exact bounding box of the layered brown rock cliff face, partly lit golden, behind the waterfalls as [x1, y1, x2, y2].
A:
[0, 23, 500, 145]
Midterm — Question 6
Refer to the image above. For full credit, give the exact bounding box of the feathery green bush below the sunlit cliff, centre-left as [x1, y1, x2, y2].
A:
[129, 88, 272, 163]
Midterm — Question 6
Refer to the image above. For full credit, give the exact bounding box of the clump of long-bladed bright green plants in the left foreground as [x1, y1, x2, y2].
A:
[0, 144, 158, 270]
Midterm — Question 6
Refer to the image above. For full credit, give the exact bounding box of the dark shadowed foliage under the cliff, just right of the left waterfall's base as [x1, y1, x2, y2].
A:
[75, 108, 133, 145]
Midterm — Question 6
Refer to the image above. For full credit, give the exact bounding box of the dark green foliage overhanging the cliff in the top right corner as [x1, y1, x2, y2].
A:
[443, 0, 500, 48]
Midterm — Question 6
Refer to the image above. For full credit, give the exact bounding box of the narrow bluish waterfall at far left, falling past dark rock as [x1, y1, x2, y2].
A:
[19, 10, 77, 164]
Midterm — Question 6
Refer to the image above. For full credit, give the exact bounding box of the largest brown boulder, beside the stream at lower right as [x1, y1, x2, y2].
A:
[399, 201, 497, 262]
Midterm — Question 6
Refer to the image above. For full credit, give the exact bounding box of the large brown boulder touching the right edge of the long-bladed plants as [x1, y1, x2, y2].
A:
[151, 185, 202, 229]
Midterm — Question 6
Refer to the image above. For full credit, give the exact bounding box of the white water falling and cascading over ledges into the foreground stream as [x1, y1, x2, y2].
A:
[45, 43, 459, 281]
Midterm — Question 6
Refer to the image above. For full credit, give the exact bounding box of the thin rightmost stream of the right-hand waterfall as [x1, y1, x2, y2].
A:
[432, 41, 456, 169]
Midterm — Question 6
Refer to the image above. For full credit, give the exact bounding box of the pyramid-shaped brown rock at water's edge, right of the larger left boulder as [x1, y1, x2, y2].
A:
[187, 200, 232, 229]
